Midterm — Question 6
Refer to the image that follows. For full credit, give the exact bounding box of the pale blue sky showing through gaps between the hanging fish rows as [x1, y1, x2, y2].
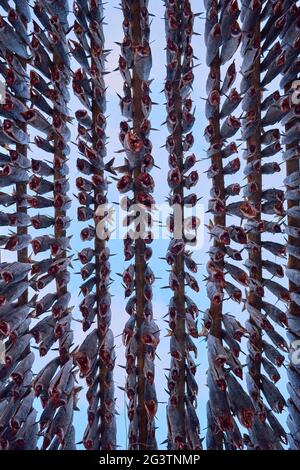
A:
[1, 0, 285, 449]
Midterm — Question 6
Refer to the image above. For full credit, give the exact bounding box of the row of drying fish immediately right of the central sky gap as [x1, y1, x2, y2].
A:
[164, 1, 202, 450]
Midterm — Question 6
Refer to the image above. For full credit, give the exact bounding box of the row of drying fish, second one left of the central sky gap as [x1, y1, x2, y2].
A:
[70, 2, 116, 450]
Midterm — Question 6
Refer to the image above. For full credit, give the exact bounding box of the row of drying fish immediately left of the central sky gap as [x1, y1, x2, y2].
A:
[117, 0, 159, 450]
